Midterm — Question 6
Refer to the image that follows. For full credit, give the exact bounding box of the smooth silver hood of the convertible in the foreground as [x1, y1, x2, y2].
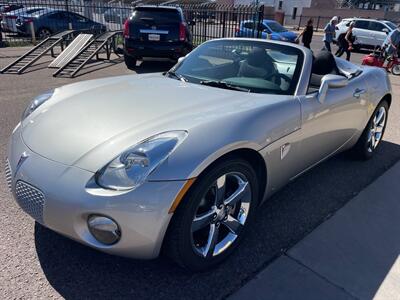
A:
[22, 74, 290, 171]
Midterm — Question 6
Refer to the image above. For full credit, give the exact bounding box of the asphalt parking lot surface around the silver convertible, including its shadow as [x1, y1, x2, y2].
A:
[0, 36, 400, 299]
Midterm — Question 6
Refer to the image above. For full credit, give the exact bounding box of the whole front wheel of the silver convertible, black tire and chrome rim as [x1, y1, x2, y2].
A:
[164, 158, 259, 271]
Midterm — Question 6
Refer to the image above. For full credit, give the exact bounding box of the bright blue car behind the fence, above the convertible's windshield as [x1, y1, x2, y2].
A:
[235, 19, 297, 42]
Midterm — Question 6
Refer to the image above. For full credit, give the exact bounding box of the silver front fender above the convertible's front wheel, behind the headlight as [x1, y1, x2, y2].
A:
[148, 97, 301, 181]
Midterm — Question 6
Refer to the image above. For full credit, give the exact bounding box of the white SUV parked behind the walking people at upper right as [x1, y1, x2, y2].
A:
[336, 18, 397, 50]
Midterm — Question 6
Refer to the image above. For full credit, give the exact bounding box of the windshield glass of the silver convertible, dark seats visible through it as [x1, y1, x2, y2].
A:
[177, 43, 297, 94]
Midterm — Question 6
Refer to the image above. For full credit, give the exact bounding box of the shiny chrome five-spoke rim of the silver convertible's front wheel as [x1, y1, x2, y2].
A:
[191, 172, 252, 258]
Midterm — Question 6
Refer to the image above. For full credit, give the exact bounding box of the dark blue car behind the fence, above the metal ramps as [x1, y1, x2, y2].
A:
[16, 8, 106, 39]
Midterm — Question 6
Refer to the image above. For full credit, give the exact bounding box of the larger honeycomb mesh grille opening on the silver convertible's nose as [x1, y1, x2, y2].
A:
[15, 180, 44, 223]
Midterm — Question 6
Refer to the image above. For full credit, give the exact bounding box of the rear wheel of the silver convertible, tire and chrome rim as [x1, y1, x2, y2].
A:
[353, 100, 389, 160]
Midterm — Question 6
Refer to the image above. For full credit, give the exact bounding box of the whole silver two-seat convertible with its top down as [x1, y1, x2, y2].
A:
[6, 39, 392, 271]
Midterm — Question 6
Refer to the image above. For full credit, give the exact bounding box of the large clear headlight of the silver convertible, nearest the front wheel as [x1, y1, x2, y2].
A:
[96, 131, 187, 190]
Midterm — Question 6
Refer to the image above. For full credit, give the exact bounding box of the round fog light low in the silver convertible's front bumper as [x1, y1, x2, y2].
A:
[88, 215, 121, 245]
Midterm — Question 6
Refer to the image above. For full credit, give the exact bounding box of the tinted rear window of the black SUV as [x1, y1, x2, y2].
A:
[132, 8, 181, 25]
